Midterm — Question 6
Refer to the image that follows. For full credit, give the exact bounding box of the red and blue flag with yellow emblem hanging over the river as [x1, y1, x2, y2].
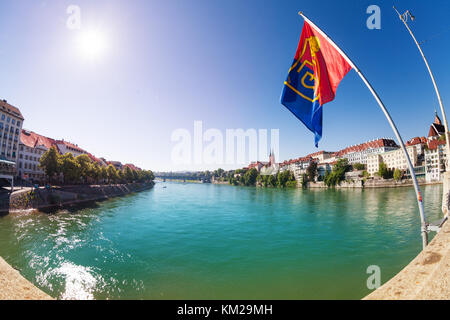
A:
[281, 21, 352, 147]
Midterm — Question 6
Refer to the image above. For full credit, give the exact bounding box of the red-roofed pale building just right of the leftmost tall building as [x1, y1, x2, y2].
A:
[17, 130, 56, 182]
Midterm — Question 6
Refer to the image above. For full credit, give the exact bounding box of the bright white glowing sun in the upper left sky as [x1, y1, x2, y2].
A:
[77, 29, 107, 60]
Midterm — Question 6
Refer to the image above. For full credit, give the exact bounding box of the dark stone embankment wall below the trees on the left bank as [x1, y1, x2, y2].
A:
[0, 182, 154, 215]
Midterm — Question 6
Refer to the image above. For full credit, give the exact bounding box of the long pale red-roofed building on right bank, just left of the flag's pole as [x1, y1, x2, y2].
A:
[335, 138, 399, 165]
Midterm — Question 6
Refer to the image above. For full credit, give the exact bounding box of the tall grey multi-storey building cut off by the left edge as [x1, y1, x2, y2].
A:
[0, 100, 24, 163]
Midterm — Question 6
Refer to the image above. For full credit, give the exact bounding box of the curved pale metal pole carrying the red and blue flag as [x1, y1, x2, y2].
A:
[298, 12, 428, 248]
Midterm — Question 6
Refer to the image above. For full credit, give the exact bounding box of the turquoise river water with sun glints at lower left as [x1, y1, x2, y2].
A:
[0, 183, 442, 299]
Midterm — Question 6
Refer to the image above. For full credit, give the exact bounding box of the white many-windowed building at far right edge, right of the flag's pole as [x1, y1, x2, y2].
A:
[425, 139, 447, 182]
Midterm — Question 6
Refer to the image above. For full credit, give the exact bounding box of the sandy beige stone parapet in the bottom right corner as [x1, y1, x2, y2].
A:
[364, 221, 450, 300]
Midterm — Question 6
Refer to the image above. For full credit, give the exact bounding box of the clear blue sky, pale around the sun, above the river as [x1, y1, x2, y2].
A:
[0, 0, 450, 171]
